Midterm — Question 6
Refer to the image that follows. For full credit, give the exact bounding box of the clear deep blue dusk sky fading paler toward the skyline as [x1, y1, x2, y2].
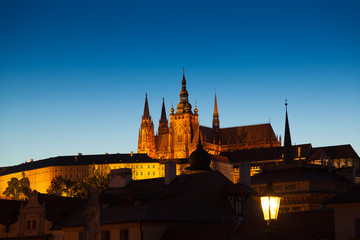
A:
[0, 0, 360, 166]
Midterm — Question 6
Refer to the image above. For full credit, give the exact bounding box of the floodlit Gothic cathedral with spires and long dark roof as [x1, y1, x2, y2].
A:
[138, 73, 281, 159]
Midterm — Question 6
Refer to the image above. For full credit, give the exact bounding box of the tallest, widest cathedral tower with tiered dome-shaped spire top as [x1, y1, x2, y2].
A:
[169, 71, 199, 158]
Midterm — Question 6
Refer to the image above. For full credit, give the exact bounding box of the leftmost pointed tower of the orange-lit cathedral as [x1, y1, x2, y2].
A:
[138, 94, 156, 158]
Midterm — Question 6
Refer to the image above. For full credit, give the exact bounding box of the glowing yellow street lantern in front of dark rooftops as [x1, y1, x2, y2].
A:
[260, 182, 281, 238]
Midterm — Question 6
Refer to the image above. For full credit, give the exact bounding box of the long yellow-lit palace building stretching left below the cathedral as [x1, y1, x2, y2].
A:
[0, 153, 189, 196]
